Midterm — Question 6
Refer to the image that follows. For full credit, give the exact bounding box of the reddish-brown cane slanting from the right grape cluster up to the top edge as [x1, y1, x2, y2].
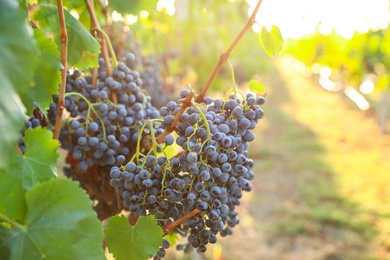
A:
[195, 0, 263, 103]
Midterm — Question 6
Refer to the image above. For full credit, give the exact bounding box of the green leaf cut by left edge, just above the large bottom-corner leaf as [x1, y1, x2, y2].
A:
[0, 166, 26, 222]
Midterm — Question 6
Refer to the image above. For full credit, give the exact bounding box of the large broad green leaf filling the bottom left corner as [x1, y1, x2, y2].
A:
[0, 179, 105, 259]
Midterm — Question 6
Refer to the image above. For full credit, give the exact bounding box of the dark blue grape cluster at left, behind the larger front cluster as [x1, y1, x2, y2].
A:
[60, 53, 159, 172]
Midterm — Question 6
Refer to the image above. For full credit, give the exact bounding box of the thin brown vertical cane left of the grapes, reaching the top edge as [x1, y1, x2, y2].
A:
[53, 0, 68, 139]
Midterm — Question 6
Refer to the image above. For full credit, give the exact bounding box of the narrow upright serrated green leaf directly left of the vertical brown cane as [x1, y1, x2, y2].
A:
[27, 29, 63, 115]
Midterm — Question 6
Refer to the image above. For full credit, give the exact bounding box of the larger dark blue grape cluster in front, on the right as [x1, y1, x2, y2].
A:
[110, 90, 265, 258]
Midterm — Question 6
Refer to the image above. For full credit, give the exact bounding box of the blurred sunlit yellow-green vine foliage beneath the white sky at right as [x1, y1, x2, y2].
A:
[285, 27, 390, 89]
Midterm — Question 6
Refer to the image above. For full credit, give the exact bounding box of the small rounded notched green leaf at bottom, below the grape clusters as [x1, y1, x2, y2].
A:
[104, 216, 163, 260]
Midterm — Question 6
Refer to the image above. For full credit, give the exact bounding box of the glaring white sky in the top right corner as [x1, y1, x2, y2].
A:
[247, 0, 390, 38]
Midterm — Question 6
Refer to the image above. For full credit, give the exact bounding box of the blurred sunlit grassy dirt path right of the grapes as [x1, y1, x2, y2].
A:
[208, 59, 390, 260]
